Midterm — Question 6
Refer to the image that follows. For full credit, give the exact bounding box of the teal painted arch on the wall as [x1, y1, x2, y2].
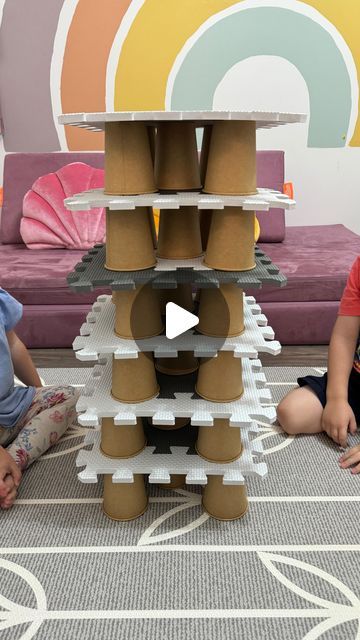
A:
[171, 7, 352, 147]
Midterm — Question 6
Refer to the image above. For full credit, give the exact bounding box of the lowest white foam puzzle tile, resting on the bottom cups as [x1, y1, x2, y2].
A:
[76, 430, 267, 485]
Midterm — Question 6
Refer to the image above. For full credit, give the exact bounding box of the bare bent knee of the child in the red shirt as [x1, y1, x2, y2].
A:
[277, 386, 323, 435]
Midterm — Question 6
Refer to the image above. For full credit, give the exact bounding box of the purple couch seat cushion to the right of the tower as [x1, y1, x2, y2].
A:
[252, 224, 360, 302]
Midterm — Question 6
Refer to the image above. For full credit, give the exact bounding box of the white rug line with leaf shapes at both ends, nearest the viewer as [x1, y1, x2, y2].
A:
[0, 552, 360, 640]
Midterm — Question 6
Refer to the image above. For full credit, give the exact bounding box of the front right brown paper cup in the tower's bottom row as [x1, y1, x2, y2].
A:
[202, 476, 248, 520]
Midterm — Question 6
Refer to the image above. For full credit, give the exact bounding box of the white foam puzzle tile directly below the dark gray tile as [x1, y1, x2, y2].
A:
[73, 296, 281, 360]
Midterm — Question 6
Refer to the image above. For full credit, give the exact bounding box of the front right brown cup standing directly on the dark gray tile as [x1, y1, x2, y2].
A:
[204, 207, 256, 271]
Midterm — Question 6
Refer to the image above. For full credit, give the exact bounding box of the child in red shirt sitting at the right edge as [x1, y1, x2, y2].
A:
[277, 257, 360, 473]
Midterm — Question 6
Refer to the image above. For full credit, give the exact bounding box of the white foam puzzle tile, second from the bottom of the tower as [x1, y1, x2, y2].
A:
[76, 356, 276, 427]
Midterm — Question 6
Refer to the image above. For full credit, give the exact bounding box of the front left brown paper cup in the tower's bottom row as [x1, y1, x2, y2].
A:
[103, 472, 148, 521]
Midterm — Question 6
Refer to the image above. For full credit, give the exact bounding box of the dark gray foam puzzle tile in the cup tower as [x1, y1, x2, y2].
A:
[67, 245, 286, 292]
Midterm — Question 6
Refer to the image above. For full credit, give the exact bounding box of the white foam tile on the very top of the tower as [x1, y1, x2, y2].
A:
[58, 110, 306, 131]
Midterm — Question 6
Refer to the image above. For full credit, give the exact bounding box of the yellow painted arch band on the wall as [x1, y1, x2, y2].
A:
[114, 0, 360, 146]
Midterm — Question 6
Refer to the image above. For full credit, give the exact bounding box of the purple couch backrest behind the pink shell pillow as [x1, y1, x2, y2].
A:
[0, 152, 104, 244]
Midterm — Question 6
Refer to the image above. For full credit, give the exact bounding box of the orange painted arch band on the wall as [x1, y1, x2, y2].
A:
[61, 0, 131, 151]
